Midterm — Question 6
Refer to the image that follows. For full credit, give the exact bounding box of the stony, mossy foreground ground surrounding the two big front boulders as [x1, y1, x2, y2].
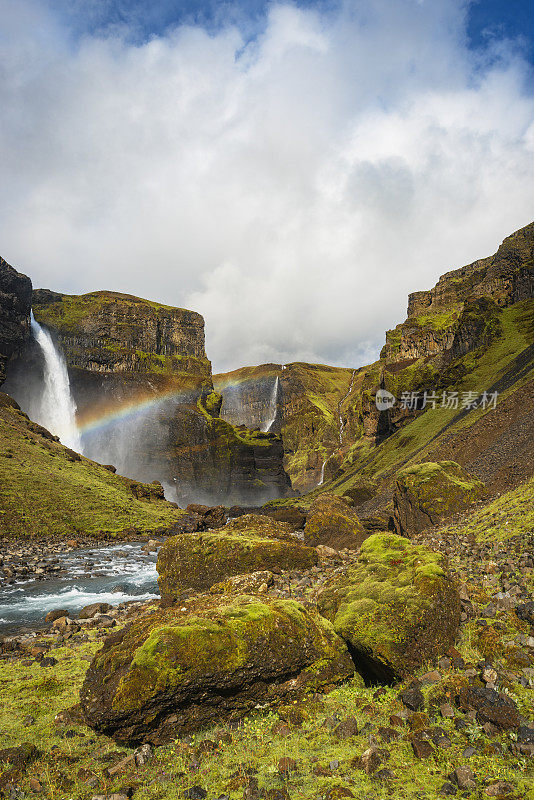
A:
[0, 478, 534, 800]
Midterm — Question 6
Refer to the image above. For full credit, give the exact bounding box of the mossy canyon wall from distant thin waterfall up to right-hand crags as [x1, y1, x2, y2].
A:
[214, 223, 534, 491]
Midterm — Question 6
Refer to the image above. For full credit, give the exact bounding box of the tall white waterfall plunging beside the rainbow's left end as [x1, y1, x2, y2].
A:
[31, 312, 82, 453]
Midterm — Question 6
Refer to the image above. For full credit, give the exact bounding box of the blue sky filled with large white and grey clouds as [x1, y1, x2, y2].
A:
[0, 0, 534, 371]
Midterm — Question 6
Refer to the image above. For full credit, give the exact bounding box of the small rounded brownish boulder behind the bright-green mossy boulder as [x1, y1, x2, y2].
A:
[304, 494, 368, 550]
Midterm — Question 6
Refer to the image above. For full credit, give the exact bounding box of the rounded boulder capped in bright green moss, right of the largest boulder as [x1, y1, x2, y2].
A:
[318, 533, 460, 680]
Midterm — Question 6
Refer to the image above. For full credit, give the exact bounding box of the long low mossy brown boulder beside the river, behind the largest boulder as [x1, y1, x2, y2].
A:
[157, 517, 317, 598]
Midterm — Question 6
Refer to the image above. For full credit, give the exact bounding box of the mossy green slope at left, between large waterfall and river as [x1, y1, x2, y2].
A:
[0, 398, 184, 536]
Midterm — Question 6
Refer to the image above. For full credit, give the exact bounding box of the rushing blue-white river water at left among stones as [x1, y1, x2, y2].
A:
[0, 543, 159, 635]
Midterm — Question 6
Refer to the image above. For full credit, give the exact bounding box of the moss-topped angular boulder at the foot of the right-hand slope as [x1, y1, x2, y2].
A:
[393, 461, 486, 535]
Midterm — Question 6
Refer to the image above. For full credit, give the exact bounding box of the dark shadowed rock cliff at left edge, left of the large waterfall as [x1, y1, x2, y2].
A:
[0, 258, 32, 386]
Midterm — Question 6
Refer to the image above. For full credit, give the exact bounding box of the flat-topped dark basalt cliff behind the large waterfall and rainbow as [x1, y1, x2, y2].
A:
[6, 289, 291, 505]
